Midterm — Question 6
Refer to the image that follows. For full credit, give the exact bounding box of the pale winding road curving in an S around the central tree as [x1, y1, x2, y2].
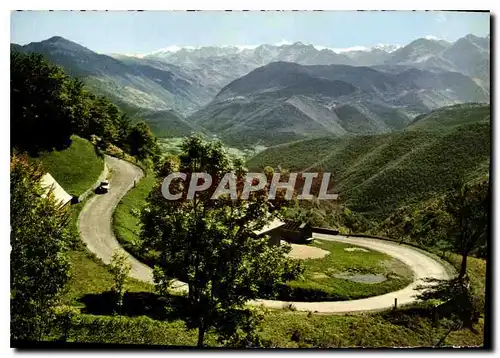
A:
[78, 156, 449, 314]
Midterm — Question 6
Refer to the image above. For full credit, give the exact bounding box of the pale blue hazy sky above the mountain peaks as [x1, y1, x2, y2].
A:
[11, 11, 490, 53]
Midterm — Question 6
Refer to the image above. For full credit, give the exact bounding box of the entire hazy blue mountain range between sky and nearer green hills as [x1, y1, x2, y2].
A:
[11, 35, 490, 146]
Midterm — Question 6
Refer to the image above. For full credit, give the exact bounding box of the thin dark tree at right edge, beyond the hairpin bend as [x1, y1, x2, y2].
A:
[445, 179, 490, 278]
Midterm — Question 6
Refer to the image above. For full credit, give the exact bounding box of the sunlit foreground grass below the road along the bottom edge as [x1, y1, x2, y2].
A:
[57, 246, 485, 348]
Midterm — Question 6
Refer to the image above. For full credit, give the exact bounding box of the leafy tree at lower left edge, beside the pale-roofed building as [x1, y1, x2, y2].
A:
[10, 154, 71, 340]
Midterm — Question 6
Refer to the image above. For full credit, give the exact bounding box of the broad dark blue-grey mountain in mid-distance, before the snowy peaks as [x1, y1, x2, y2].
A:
[188, 62, 489, 147]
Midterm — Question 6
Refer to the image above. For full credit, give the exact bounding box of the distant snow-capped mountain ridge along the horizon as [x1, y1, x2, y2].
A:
[144, 35, 490, 88]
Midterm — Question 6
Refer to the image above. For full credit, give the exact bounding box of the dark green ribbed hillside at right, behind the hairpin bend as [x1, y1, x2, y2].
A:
[247, 106, 491, 216]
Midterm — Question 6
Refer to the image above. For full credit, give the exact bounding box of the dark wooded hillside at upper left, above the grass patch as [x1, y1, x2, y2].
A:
[11, 50, 159, 165]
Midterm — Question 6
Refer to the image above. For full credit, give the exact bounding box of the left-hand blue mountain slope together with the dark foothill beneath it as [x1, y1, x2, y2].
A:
[11, 37, 206, 136]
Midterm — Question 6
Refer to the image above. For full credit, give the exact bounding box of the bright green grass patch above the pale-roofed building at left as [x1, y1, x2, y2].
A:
[38, 135, 104, 196]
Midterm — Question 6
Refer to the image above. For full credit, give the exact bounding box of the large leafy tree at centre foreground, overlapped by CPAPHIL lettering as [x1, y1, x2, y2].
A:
[141, 136, 301, 347]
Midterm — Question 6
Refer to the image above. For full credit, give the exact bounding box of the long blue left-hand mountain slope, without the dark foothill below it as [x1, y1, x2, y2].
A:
[15, 36, 210, 113]
